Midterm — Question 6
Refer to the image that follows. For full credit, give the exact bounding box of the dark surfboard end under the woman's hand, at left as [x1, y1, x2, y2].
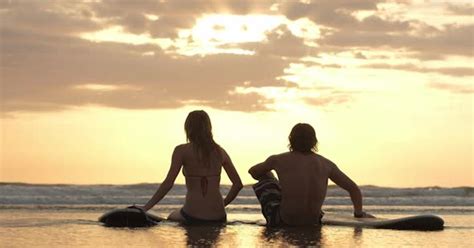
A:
[99, 207, 163, 227]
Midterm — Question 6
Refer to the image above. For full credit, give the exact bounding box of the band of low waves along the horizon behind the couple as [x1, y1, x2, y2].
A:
[0, 183, 474, 206]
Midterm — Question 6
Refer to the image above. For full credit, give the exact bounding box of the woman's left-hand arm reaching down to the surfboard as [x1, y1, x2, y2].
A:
[142, 146, 183, 211]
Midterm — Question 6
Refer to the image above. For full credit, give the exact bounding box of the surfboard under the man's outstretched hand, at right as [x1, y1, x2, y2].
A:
[322, 213, 444, 231]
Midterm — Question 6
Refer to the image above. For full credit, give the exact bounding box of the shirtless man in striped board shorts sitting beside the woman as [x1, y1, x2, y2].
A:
[249, 123, 374, 226]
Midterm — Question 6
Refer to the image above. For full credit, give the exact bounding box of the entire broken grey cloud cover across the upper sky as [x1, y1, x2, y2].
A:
[0, 0, 474, 115]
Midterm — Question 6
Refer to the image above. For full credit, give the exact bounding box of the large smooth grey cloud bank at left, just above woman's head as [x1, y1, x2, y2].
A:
[1, 24, 287, 111]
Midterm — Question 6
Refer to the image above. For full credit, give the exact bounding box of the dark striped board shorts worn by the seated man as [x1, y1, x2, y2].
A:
[252, 178, 324, 227]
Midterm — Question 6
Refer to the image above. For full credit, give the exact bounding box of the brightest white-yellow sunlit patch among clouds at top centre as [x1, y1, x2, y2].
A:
[80, 14, 286, 56]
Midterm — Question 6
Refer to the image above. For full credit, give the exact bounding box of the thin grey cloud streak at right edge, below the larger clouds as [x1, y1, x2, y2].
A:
[362, 64, 474, 77]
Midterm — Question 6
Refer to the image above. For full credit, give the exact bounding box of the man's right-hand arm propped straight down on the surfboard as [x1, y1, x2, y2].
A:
[328, 160, 374, 218]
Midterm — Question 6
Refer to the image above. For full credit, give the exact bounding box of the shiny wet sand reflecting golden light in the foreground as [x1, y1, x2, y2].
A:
[0, 210, 474, 247]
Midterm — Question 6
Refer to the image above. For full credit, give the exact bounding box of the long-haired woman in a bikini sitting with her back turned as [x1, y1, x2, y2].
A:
[136, 110, 242, 224]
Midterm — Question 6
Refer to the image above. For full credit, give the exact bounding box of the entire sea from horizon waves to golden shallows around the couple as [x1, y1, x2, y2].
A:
[0, 183, 474, 247]
